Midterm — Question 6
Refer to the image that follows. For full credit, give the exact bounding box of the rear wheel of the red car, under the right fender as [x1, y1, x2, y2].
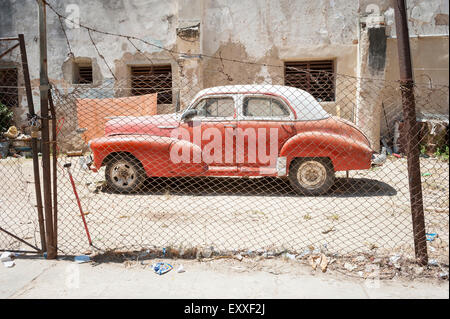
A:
[289, 157, 335, 196]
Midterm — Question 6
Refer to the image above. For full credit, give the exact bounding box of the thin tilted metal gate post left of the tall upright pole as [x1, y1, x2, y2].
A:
[19, 34, 47, 251]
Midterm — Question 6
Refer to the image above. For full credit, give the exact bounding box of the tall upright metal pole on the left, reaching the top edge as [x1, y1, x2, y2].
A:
[39, 0, 56, 259]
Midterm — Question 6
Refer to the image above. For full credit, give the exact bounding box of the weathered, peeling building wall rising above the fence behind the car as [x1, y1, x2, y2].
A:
[0, 0, 449, 148]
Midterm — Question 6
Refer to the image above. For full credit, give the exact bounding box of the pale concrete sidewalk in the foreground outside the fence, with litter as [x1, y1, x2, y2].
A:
[0, 258, 449, 299]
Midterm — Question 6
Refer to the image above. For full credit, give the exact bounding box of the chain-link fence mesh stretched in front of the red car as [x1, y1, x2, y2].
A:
[44, 70, 449, 270]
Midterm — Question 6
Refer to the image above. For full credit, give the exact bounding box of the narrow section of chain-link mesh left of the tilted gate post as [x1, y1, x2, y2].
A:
[0, 65, 40, 251]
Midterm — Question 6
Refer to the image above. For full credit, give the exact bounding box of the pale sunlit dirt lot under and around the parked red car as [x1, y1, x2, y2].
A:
[0, 157, 449, 278]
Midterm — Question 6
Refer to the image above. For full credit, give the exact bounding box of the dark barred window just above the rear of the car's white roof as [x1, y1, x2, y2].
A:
[284, 60, 336, 102]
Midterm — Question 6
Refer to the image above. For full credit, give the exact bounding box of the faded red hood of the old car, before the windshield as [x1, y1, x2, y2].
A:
[105, 113, 180, 136]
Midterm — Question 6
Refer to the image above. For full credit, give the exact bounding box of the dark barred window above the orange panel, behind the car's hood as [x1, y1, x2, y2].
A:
[131, 65, 172, 104]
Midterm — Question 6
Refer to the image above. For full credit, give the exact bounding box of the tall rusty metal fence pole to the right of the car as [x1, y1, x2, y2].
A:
[392, 0, 428, 265]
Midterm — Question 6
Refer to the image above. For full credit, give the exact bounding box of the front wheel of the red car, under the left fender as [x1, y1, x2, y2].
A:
[105, 154, 146, 193]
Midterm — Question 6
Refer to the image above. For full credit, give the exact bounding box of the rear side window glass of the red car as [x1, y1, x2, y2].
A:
[243, 97, 290, 117]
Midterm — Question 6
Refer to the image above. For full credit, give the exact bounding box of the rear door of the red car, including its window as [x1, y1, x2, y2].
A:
[236, 94, 295, 175]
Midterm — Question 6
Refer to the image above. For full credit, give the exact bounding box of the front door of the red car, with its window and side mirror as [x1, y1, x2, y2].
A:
[180, 95, 237, 175]
